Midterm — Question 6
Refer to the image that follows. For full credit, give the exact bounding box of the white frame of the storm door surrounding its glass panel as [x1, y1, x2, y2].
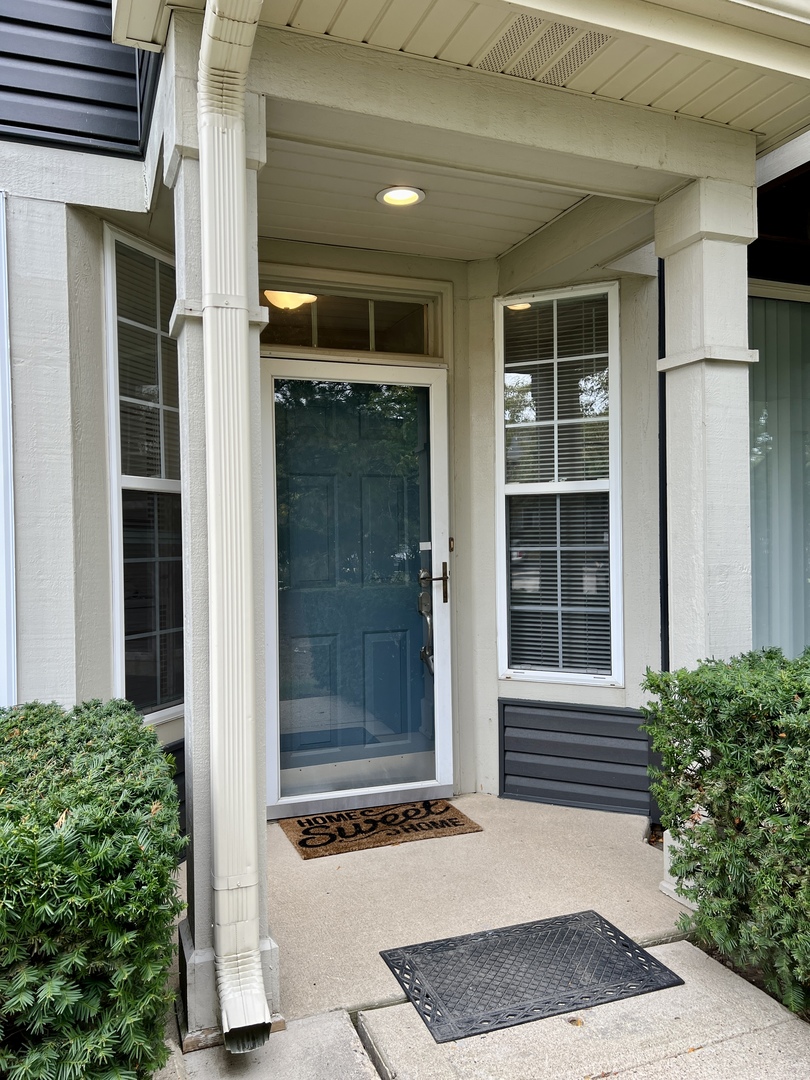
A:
[261, 359, 453, 818]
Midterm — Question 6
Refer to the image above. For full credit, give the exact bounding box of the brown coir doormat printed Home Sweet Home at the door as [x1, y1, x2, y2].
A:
[279, 799, 482, 859]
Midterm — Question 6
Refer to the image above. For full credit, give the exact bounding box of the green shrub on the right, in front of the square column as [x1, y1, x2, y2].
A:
[643, 649, 810, 1011]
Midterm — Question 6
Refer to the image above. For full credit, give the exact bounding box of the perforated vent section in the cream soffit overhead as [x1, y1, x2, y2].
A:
[472, 15, 610, 86]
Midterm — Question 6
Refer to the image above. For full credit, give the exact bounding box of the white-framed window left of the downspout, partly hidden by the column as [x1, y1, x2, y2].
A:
[105, 227, 184, 723]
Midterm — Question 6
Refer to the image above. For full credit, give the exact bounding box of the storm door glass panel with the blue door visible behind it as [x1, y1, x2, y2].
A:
[275, 379, 435, 797]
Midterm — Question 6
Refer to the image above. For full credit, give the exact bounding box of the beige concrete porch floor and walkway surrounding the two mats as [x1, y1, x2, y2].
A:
[160, 795, 810, 1080]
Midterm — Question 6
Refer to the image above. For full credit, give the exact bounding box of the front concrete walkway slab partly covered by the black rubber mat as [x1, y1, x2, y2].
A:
[357, 941, 810, 1080]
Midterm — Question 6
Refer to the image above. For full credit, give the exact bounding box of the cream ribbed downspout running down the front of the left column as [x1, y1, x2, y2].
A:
[198, 0, 270, 1053]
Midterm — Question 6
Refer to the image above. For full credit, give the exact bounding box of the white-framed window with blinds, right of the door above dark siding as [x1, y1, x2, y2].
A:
[496, 283, 623, 685]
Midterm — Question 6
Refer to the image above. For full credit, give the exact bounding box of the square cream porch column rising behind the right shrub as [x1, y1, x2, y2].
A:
[656, 179, 756, 667]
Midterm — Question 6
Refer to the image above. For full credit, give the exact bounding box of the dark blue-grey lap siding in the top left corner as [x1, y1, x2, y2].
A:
[0, 0, 160, 157]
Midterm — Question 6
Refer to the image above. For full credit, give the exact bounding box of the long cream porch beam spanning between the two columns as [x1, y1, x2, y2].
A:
[248, 27, 755, 195]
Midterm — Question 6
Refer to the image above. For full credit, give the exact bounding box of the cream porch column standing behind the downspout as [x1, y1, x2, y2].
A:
[164, 14, 281, 1050]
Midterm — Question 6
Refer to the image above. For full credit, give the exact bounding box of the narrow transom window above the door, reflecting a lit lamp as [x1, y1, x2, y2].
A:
[260, 284, 430, 356]
